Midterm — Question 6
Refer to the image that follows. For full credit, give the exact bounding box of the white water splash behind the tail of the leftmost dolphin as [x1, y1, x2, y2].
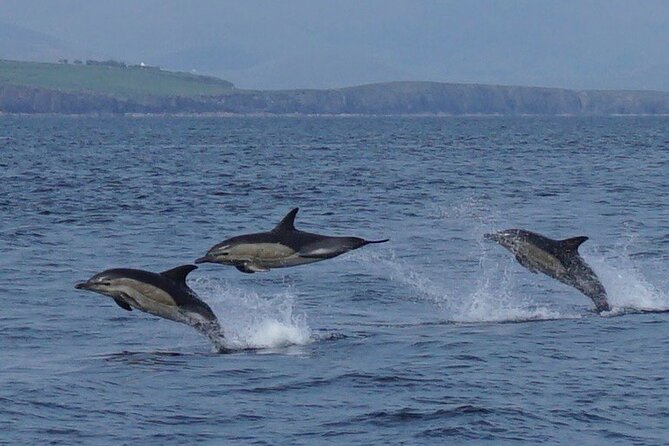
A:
[191, 278, 311, 350]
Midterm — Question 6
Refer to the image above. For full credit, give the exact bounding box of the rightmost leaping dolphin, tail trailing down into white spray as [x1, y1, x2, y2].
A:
[484, 229, 611, 313]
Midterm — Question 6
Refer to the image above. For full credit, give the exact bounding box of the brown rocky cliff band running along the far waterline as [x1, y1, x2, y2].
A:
[0, 82, 669, 115]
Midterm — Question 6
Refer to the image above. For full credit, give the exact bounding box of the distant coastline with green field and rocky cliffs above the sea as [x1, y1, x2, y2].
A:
[0, 60, 669, 116]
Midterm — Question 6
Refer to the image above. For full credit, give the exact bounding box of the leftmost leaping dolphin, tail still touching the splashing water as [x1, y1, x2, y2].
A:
[75, 265, 224, 351]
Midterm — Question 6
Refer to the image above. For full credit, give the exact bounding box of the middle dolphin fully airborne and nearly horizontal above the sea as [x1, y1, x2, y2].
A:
[195, 208, 389, 273]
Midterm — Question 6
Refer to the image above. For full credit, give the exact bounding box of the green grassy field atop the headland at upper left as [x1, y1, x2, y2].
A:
[0, 60, 233, 98]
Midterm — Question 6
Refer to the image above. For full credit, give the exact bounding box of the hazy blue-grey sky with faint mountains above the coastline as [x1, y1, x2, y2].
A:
[0, 0, 669, 91]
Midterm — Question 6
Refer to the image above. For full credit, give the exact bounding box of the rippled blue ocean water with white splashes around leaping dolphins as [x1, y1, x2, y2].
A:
[0, 116, 669, 445]
